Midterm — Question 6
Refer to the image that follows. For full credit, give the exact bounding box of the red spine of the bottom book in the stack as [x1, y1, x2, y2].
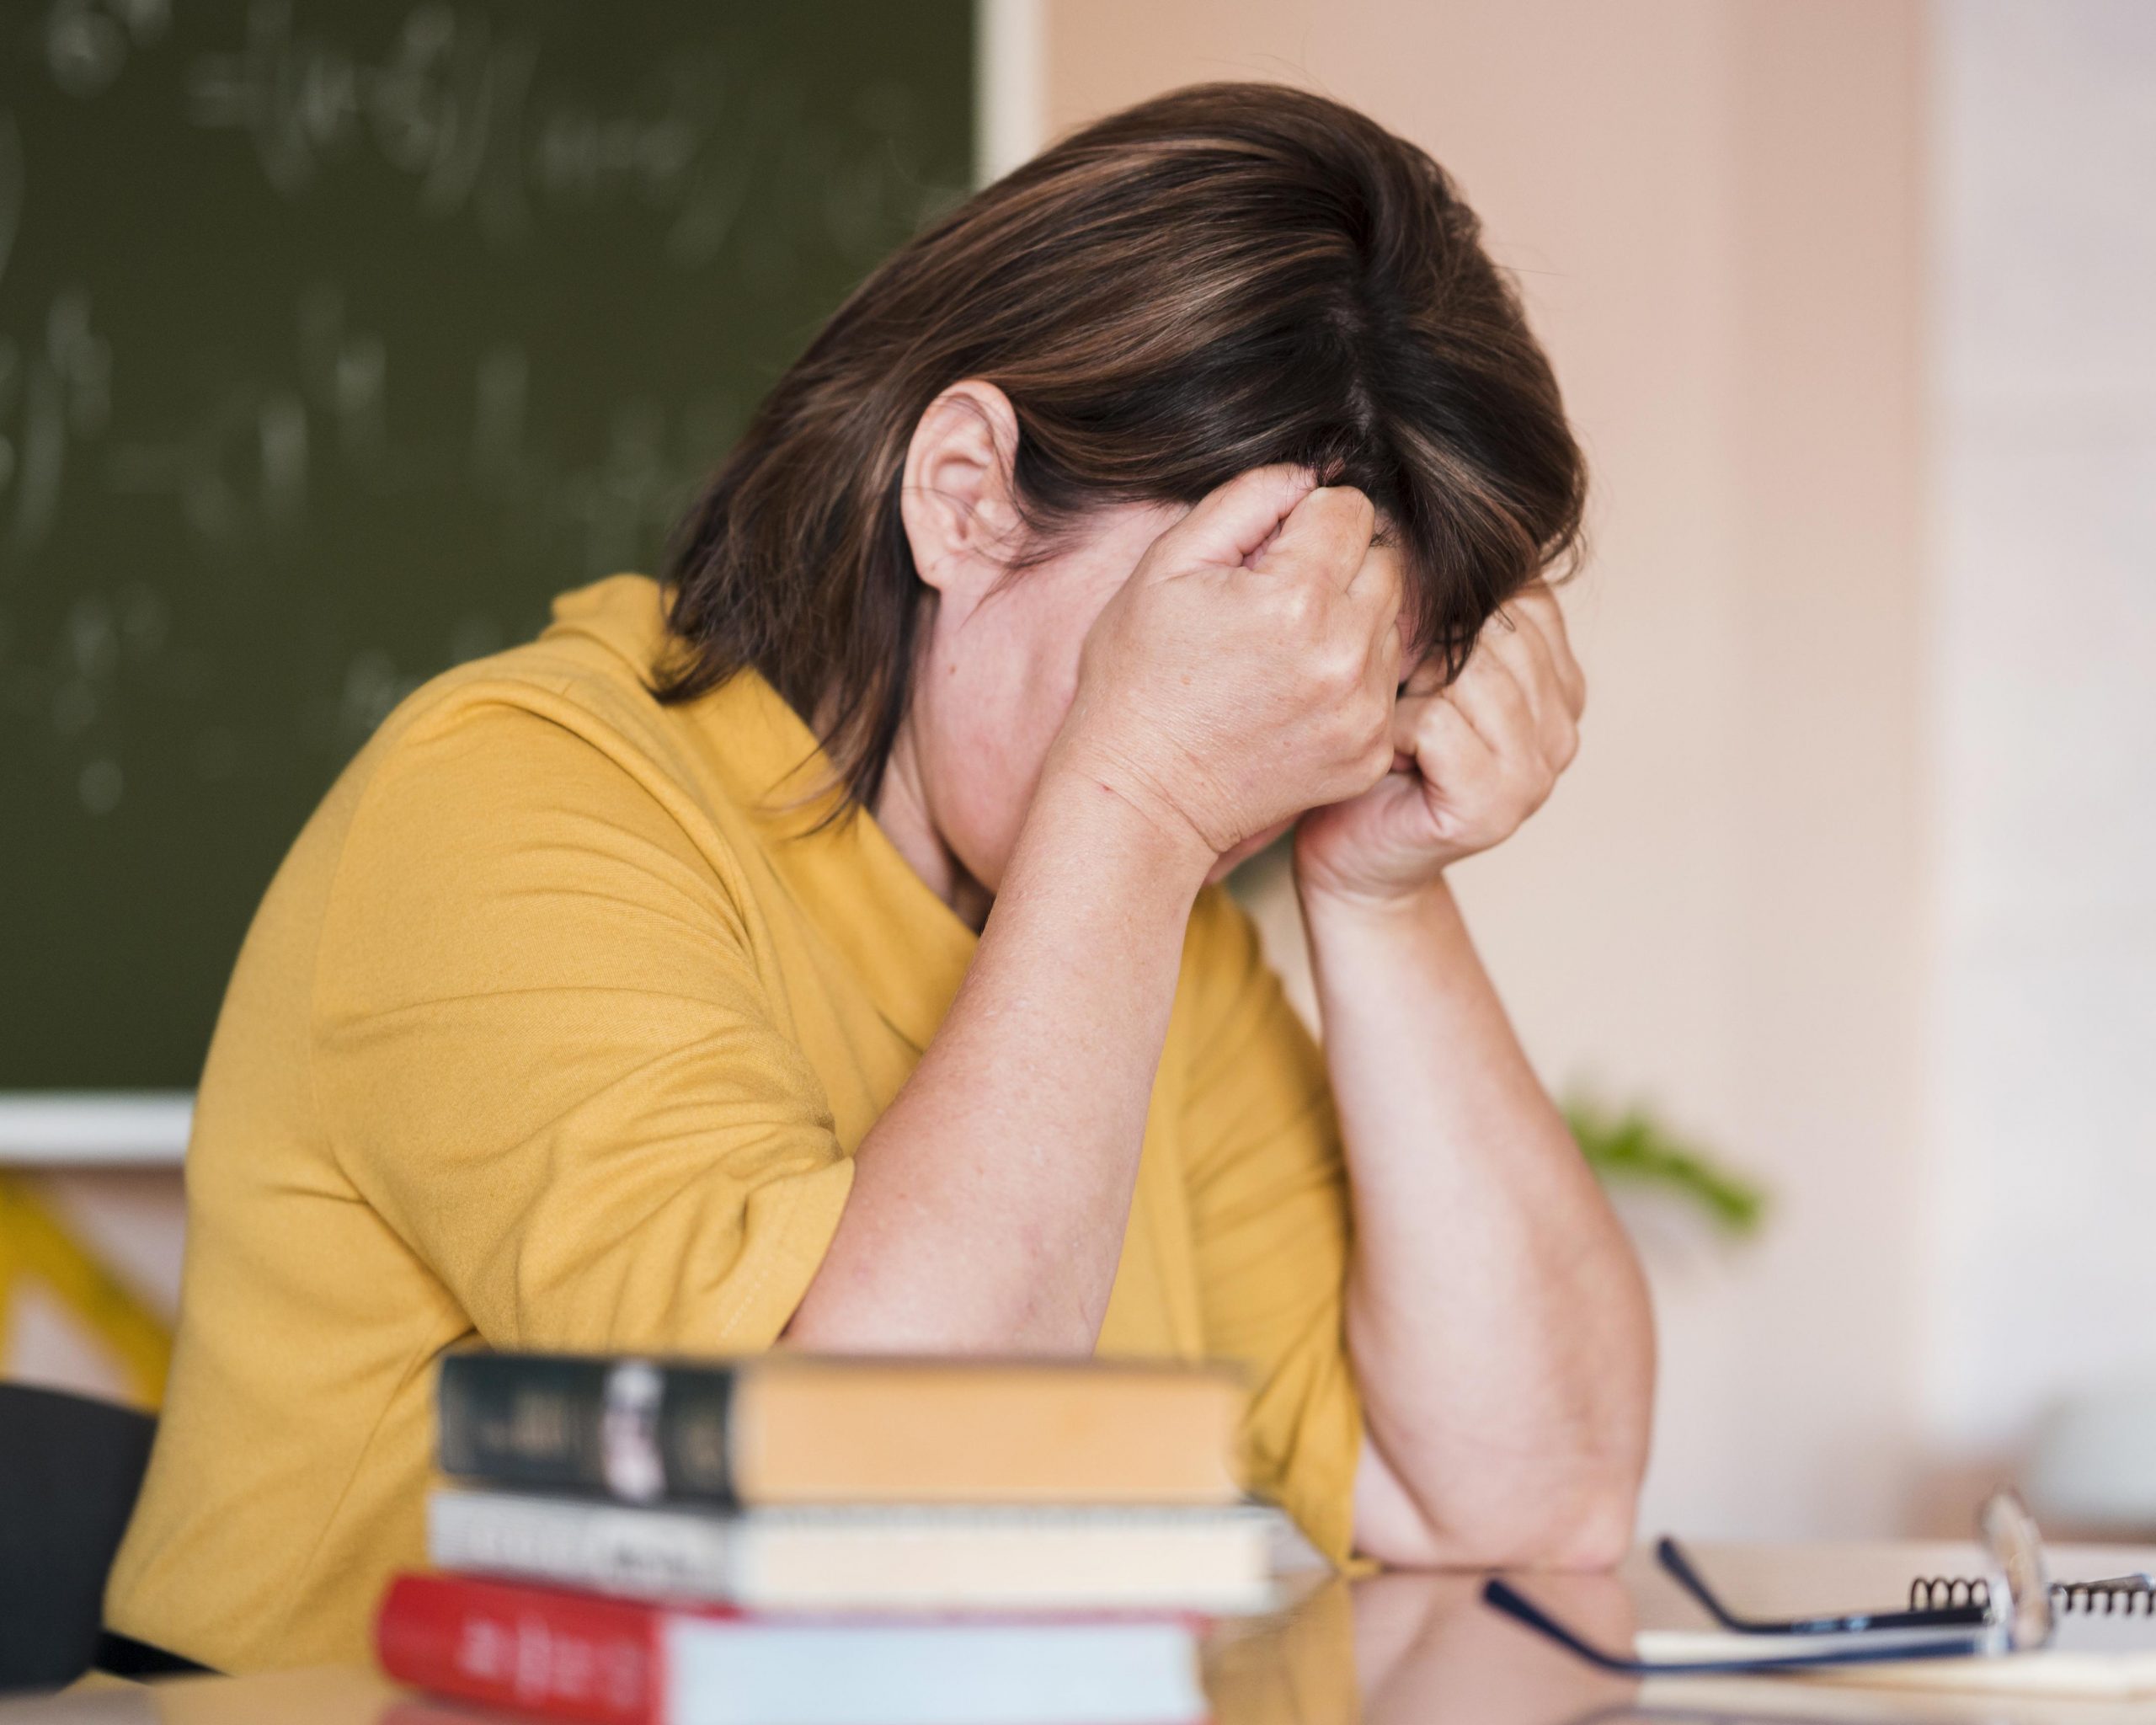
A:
[375, 1574, 666, 1725]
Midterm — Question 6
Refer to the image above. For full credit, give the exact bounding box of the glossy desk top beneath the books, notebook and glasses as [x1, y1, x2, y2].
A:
[0, 1544, 2156, 1725]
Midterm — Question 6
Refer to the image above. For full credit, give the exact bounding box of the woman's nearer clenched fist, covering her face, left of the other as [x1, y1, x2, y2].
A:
[1048, 466, 1401, 865]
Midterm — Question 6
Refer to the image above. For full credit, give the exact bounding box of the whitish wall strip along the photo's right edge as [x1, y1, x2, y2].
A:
[1928, 0, 2156, 1526]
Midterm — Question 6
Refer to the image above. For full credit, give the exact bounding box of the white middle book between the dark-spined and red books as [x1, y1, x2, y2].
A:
[427, 1487, 1283, 1613]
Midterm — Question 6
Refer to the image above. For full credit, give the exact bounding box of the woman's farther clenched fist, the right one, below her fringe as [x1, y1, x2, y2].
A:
[1296, 580, 1587, 905]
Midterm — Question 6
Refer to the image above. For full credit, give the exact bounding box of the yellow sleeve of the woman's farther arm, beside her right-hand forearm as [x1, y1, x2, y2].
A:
[1183, 890, 1363, 1563]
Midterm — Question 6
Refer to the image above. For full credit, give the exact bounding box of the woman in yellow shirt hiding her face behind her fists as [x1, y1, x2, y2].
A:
[108, 86, 1652, 1669]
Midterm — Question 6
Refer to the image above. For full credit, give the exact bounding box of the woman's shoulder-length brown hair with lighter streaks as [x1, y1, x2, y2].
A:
[659, 84, 1585, 804]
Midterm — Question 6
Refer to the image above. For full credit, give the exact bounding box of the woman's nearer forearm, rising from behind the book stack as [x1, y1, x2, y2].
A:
[787, 766, 1212, 1352]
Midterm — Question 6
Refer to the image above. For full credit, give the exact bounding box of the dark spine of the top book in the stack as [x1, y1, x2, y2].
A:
[438, 1354, 735, 1505]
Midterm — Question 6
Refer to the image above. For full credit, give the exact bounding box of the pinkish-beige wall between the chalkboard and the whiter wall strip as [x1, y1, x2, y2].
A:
[1043, 0, 1924, 1533]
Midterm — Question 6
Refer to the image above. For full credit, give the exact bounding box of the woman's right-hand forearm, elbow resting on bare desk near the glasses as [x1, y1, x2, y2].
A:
[1305, 879, 1654, 1563]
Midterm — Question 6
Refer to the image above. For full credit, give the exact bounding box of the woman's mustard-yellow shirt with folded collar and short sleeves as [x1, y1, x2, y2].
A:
[105, 576, 1360, 1671]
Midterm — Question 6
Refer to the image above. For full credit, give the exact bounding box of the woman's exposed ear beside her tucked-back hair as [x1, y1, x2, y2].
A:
[899, 377, 1017, 604]
